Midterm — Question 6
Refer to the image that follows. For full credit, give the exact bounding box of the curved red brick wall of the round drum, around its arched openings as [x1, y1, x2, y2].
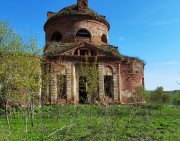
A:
[44, 15, 108, 45]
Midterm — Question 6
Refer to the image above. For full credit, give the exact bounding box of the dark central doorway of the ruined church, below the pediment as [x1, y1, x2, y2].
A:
[79, 76, 87, 104]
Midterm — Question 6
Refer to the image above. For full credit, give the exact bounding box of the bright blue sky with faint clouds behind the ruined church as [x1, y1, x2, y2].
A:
[0, 0, 180, 90]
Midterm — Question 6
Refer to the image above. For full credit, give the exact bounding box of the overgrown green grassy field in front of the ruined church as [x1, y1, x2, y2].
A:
[0, 105, 180, 141]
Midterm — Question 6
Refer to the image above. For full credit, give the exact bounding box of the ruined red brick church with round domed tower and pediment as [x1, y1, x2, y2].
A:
[42, 0, 144, 104]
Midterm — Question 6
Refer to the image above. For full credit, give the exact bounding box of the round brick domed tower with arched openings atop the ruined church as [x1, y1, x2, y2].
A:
[44, 0, 110, 45]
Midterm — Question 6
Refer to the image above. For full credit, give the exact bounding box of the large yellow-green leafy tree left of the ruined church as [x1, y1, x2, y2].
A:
[0, 21, 41, 132]
